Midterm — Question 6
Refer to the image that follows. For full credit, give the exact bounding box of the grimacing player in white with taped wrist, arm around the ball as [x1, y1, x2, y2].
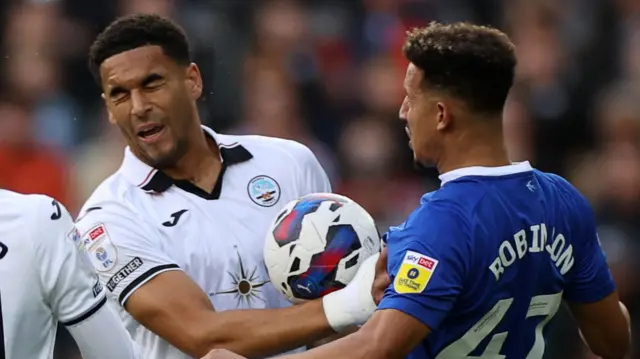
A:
[77, 14, 384, 359]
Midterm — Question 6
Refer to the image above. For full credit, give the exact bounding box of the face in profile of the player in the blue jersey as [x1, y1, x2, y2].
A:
[400, 64, 439, 166]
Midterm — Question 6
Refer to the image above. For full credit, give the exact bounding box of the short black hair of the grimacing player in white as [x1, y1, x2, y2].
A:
[89, 14, 191, 84]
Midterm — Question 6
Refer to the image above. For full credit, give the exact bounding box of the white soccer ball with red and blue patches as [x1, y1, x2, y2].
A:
[264, 193, 380, 303]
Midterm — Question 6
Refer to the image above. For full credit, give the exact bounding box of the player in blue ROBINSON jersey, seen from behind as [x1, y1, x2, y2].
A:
[205, 23, 630, 359]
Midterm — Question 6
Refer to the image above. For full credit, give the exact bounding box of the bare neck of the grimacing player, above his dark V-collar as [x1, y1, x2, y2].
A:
[164, 128, 222, 191]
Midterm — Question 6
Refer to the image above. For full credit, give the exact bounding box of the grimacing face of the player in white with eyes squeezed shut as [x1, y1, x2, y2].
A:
[100, 46, 202, 168]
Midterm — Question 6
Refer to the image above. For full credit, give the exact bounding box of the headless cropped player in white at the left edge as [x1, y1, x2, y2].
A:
[0, 190, 137, 359]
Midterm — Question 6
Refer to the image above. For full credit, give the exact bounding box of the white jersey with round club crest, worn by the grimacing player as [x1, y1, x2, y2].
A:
[76, 127, 331, 359]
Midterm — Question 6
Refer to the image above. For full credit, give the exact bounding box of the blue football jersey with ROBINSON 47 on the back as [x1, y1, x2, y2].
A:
[378, 162, 615, 359]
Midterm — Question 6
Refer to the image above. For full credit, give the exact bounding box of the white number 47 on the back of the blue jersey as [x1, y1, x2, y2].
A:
[436, 293, 562, 359]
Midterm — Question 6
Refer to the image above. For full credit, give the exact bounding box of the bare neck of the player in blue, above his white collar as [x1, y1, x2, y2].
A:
[437, 122, 511, 173]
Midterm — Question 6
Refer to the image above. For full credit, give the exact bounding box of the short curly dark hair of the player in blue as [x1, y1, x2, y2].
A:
[402, 22, 517, 114]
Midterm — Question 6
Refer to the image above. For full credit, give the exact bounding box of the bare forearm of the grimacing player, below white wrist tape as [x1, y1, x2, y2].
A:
[200, 300, 335, 358]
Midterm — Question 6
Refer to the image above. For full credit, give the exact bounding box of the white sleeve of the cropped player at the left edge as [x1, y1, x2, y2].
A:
[32, 197, 138, 359]
